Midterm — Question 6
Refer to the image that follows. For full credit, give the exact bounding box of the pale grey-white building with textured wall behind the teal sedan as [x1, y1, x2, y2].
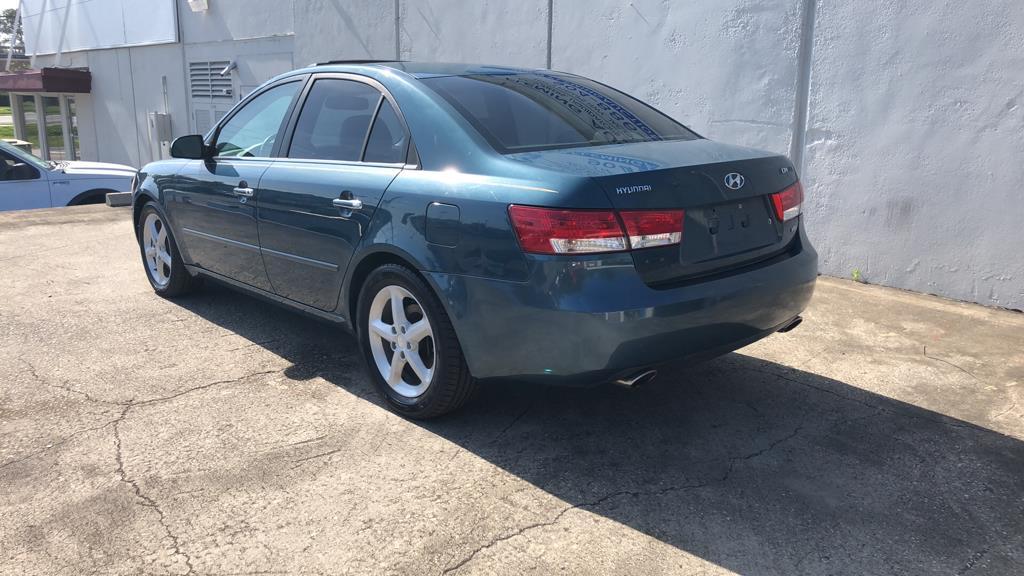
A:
[0, 0, 1024, 308]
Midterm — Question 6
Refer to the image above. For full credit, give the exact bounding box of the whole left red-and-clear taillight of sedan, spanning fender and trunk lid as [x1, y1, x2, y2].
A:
[509, 205, 683, 254]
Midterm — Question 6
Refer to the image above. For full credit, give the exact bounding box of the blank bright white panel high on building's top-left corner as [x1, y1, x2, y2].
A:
[22, 0, 177, 54]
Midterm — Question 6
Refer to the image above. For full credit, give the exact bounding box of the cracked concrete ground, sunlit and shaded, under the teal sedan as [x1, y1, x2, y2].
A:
[0, 207, 1024, 575]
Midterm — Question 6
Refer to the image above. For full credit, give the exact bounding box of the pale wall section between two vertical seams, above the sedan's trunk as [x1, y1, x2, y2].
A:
[551, 0, 801, 154]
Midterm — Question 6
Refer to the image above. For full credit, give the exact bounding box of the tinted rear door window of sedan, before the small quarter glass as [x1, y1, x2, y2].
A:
[288, 78, 381, 161]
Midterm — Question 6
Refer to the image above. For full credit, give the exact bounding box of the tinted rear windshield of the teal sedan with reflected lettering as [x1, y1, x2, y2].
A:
[423, 73, 697, 154]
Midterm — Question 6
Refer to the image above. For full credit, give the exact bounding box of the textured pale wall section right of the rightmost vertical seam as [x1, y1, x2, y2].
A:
[804, 0, 1024, 308]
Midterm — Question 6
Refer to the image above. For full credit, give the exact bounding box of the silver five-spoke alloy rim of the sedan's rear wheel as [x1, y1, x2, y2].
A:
[368, 285, 437, 400]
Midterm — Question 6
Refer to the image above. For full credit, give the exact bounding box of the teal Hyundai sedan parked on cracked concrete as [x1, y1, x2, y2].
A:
[133, 61, 817, 418]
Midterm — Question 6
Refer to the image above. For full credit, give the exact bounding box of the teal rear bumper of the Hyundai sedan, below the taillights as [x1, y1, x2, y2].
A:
[427, 226, 817, 385]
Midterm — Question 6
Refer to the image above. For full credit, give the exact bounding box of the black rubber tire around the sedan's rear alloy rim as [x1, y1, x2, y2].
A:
[356, 263, 475, 420]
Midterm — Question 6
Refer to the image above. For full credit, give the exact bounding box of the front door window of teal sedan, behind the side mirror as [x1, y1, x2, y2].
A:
[217, 82, 302, 158]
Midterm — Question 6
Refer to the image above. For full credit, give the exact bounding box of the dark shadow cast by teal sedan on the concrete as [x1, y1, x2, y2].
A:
[172, 287, 1024, 574]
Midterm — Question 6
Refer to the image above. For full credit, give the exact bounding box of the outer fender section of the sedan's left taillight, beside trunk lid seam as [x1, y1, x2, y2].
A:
[509, 206, 629, 254]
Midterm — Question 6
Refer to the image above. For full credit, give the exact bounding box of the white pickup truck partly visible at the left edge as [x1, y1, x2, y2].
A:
[0, 141, 137, 211]
